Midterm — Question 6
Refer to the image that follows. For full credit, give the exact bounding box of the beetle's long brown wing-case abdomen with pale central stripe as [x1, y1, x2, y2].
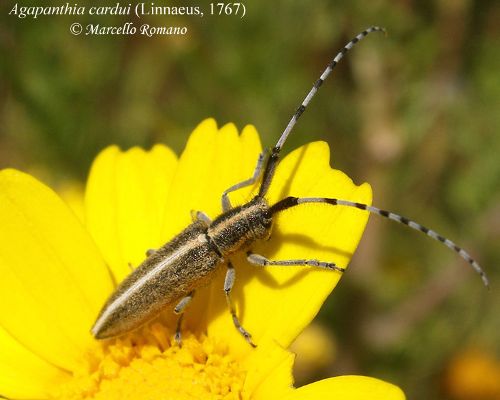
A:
[92, 221, 223, 339]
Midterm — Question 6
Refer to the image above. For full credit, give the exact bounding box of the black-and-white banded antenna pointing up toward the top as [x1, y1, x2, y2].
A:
[259, 26, 386, 197]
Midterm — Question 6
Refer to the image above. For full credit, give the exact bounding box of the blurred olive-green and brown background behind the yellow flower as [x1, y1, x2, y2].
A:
[0, 0, 500, 399]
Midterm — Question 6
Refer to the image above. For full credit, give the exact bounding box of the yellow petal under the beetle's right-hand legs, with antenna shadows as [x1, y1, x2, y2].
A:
[210, 142, 371, 355]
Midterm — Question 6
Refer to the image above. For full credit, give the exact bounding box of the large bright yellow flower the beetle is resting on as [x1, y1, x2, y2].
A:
[0, 120, 404, 400]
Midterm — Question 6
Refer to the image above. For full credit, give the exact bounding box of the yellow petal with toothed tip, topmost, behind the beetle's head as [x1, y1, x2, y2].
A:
[160, 119, 260, 237]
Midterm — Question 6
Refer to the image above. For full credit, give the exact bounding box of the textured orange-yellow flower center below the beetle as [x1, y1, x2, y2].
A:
[54, 323, 245, 400]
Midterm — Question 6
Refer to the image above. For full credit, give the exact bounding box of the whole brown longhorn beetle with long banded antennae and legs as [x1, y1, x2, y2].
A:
[92, 26, 489, 346]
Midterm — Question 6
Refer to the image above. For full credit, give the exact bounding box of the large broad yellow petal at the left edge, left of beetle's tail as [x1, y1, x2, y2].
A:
[0, 170, 112, 370]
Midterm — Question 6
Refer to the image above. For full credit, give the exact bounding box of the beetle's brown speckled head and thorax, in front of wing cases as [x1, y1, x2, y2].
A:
[208, 196, 272, 256]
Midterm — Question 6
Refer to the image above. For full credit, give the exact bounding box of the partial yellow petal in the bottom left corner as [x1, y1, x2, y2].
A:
[0, 327, 69, 399]
